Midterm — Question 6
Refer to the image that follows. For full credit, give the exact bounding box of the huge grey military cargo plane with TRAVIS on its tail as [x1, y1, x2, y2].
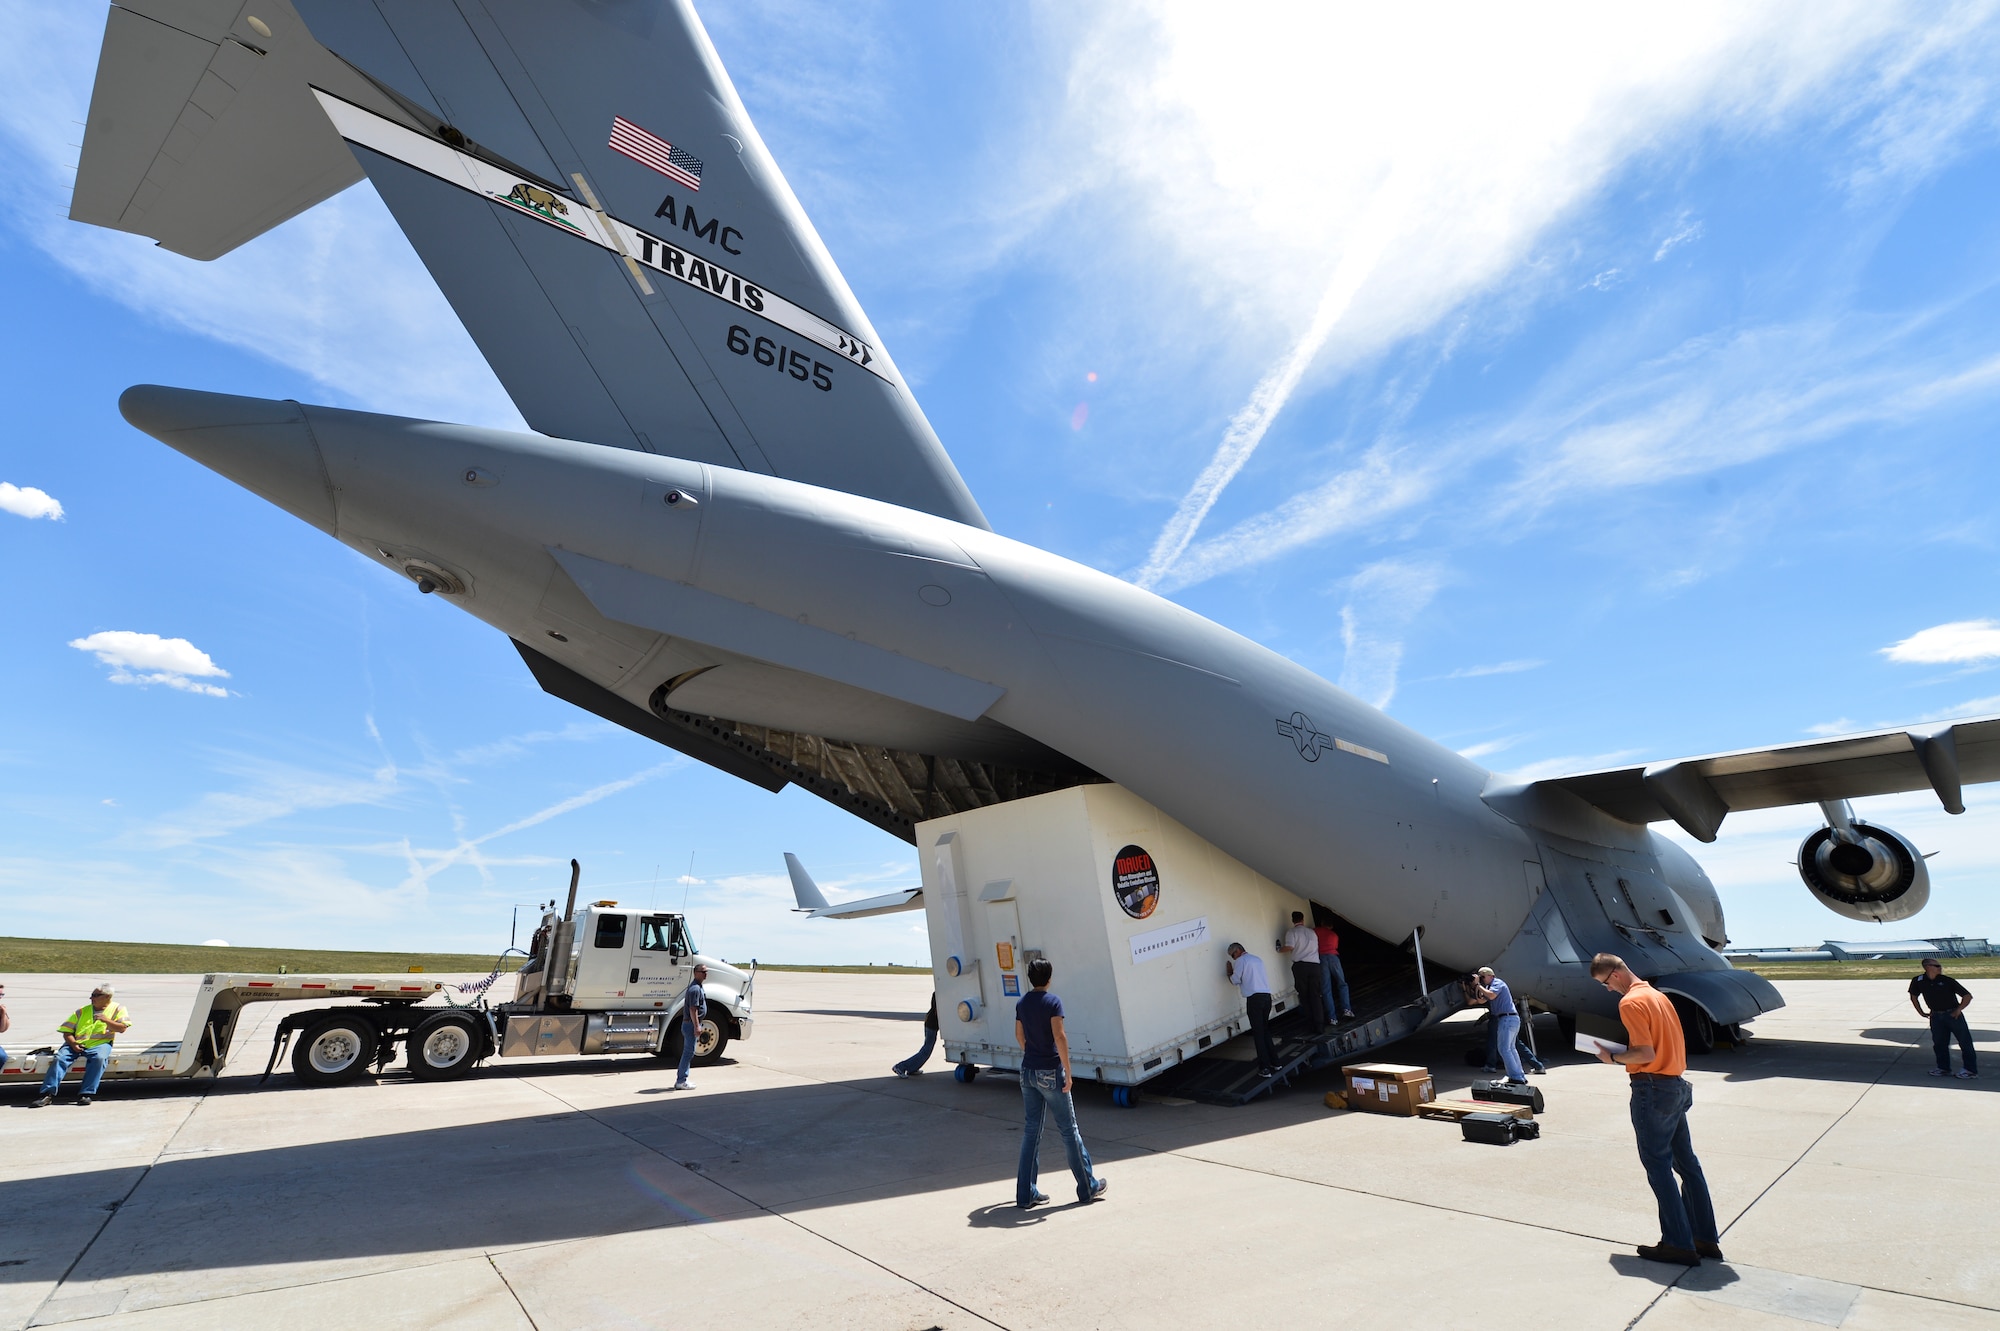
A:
[72, 0, 2000, 1055]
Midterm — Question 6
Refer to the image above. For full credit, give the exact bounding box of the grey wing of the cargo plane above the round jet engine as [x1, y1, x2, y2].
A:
[1532, 715, 2000, 841]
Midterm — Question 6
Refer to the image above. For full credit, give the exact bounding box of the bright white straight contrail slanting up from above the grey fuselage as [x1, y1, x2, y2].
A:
[1132, 178, 1402, 588]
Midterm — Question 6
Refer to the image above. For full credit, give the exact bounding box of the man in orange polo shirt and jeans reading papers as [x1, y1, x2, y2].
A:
[1590, 951, 1722, 1267]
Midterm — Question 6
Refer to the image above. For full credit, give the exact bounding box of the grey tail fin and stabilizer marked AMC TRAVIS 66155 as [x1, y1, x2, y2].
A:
[70, 0, 986, 528]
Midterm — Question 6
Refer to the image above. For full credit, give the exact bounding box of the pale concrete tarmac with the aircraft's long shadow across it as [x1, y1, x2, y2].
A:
[0, 973, 2000, 1331]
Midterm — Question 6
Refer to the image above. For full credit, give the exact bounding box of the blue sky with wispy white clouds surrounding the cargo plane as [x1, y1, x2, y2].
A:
[0, 0, 2000, 961]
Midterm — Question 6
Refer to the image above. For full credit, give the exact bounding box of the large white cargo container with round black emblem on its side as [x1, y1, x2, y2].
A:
[918, 785, 1308, 1085]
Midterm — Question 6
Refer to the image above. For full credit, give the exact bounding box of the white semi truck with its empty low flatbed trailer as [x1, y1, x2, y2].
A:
[0, 859, 756, 1085]
